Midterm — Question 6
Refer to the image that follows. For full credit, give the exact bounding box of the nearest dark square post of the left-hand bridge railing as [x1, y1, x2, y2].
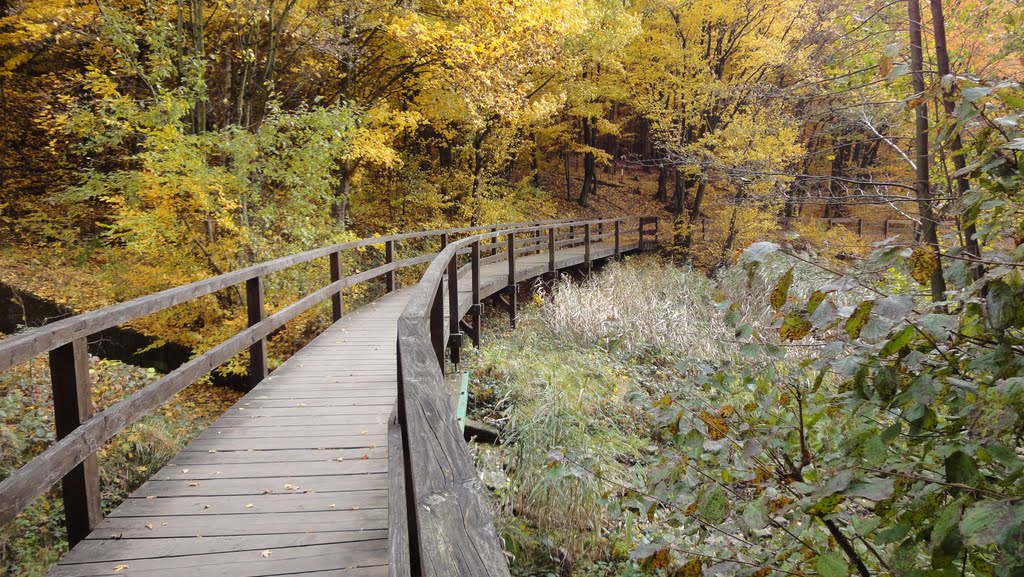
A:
[49, 338, 103, 547]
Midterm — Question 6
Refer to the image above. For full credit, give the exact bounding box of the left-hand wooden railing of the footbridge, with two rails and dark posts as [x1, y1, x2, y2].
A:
[0, 215, 647, 546]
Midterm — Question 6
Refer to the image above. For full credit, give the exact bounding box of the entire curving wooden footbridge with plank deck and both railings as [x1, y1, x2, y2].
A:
[0, 217, 657, 577]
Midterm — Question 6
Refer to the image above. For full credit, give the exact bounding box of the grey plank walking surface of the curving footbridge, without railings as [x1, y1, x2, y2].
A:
[50, 236, 639, 577]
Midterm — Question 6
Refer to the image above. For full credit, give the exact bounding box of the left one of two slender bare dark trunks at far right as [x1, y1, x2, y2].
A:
[906, 0, 946, 302]
